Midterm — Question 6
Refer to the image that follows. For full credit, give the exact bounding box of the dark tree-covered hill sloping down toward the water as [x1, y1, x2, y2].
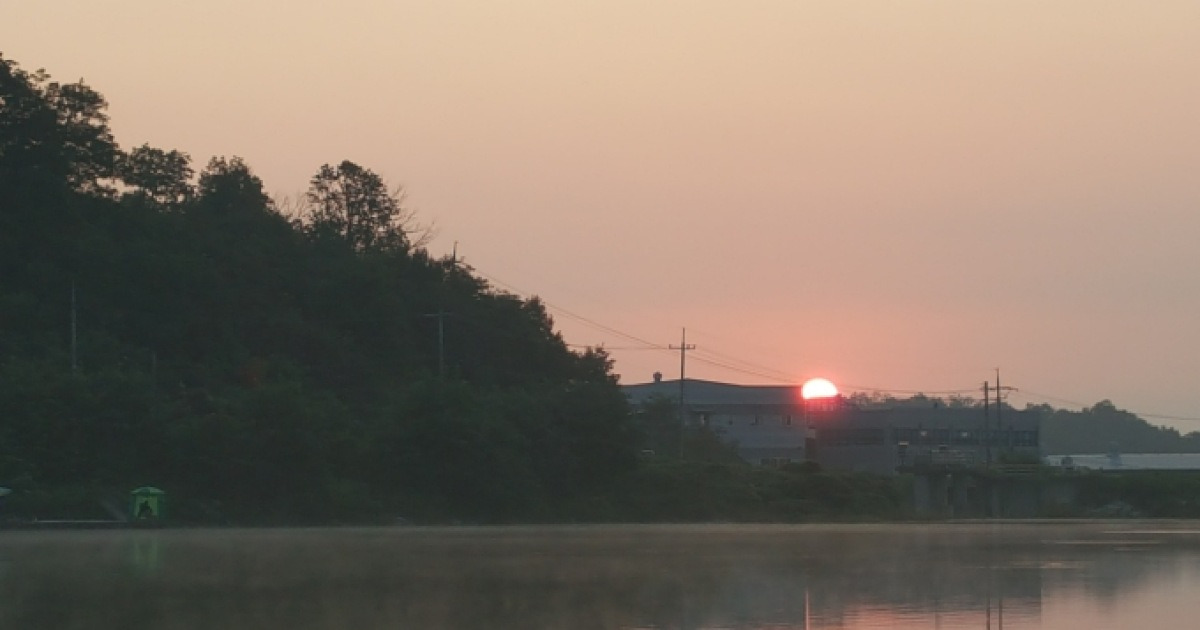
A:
[0, 58, 637, 522]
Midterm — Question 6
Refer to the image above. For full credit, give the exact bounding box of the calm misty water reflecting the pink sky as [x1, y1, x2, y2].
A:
[0, 522, 1200, 630]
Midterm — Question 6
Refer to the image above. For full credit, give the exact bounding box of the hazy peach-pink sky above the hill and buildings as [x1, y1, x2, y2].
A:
[0, 0, 1200, 431]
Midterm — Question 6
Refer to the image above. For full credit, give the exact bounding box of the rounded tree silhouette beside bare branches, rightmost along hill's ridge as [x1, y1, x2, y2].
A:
[305, 160, 419, 251]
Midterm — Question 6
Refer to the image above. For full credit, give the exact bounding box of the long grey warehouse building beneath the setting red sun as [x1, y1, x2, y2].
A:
[622, 379, 1040, 474]
